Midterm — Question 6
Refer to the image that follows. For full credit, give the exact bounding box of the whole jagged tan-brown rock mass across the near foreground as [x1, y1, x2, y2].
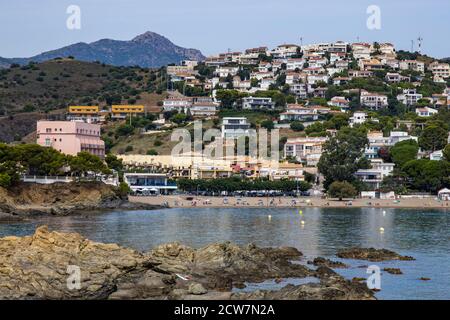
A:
[0, 227, 374, 300]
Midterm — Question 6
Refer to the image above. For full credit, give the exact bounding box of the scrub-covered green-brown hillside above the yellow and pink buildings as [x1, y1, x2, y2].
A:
[0, 59, 165, 142]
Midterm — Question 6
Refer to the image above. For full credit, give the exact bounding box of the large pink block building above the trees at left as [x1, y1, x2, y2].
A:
[37, 121, 105, 158]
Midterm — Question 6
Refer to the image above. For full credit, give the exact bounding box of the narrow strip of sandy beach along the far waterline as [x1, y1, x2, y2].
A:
[129, 195, 450, 210]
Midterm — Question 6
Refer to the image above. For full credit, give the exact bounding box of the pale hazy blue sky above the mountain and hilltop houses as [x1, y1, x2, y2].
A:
[0, 0, 450, 58]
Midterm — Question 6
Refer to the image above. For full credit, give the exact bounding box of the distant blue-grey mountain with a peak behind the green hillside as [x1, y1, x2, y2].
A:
[0, 32, 205, 68]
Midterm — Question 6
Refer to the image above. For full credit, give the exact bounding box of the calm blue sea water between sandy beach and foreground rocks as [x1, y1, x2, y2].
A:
[0, 208, 450, 299]
